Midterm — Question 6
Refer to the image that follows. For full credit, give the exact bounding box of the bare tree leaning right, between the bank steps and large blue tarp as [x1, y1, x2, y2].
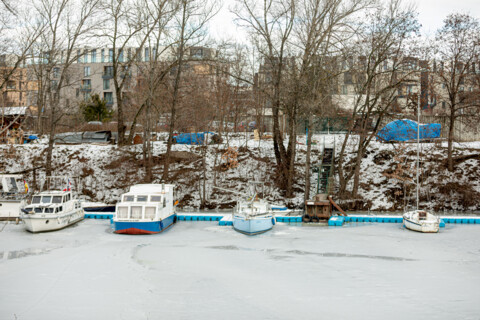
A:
[338, 0, 419, 198]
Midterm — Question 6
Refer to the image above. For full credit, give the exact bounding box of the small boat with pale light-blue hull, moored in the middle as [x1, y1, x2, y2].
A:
[233, 197, 276, 235]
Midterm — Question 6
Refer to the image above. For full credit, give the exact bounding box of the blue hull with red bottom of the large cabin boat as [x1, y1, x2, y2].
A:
[113, 214, 177, 234]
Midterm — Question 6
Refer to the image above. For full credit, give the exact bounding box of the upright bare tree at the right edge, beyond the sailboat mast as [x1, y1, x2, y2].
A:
[434, 14, 480, 171]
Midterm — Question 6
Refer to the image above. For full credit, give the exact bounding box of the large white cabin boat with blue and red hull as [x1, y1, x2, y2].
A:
[113, 184, 177, 234]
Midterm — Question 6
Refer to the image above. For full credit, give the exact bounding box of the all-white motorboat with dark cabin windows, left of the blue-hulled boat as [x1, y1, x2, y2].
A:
[20, 188, 84, 233]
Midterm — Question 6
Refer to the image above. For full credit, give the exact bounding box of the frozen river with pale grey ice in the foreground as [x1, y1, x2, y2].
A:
[0, 220, 480, 320]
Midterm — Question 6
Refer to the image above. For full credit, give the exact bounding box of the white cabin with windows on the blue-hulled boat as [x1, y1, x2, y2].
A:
[116, 184, 174, 221]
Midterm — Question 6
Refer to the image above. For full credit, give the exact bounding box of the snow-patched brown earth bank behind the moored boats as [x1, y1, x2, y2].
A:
[0, 135, 480, 212]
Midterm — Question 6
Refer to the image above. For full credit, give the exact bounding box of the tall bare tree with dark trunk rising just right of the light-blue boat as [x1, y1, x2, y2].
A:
[234, 0, 296, 197]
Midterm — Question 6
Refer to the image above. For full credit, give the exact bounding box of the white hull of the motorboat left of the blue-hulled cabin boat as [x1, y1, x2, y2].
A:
[22, 209, 84, 233]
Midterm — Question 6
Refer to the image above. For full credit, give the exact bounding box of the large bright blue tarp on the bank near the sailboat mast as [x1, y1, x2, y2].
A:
[377, 119, 442, 141]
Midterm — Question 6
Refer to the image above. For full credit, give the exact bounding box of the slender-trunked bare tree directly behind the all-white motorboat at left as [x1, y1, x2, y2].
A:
[33, 0, 99, 176]
